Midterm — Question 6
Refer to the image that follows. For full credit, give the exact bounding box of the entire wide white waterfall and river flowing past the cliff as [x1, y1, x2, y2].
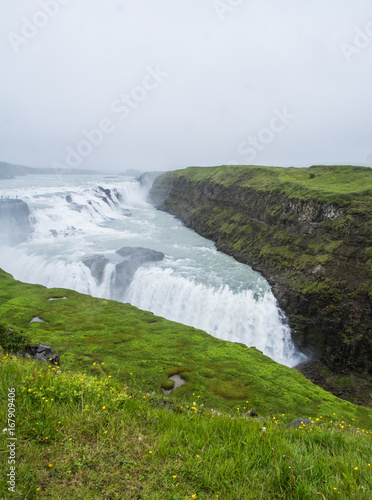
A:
[0, 176, 304, 366]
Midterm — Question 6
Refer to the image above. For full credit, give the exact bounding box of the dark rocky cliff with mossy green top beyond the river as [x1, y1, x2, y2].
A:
[150, 166, 372, 404]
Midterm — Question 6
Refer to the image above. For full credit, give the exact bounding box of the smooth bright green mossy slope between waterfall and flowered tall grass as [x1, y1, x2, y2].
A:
[0, 272, 372, 427]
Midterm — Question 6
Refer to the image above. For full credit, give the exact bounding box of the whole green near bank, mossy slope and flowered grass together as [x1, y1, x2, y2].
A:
[0, 272, 372, 500]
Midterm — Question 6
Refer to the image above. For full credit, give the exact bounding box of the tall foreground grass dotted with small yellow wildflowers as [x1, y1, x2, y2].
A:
[0, 356, 372, 500]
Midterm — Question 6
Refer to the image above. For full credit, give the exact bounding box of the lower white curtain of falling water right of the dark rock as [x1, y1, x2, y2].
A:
[124, 267, 294, 363]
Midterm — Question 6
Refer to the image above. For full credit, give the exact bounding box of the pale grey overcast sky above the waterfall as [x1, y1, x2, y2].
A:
[0, 0, 372, 172]
